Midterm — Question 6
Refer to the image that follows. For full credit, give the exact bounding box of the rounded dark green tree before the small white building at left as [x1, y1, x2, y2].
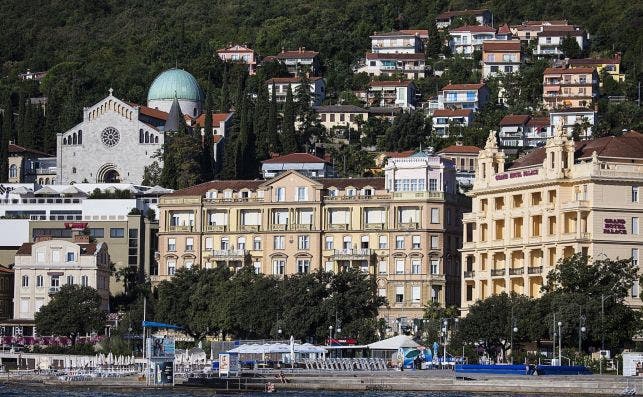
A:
[34, 285, 107, 345]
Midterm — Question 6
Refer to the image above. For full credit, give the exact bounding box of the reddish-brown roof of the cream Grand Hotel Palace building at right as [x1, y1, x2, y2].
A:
[509, 131, 643, 169]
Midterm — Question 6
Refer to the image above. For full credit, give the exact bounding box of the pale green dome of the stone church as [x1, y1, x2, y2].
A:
[147, 69, 203, 102]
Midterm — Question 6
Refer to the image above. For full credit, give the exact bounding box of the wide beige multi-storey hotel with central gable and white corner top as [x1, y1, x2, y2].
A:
[152, 152, 470, 325]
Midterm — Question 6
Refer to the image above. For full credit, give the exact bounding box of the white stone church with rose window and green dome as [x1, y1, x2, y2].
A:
[56, 69, 232, 185]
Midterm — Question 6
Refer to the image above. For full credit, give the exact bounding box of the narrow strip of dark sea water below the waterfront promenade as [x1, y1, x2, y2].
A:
[0, 384, 592, 397]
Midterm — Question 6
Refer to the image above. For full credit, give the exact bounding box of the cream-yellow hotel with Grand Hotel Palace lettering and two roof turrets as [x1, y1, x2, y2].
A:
[461, 127, 643, 313]
